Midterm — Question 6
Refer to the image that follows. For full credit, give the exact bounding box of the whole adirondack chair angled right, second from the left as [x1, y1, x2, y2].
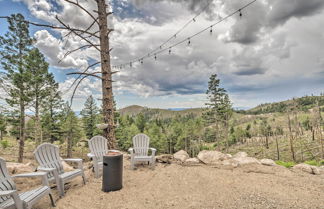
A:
[34, 143, 86, 197]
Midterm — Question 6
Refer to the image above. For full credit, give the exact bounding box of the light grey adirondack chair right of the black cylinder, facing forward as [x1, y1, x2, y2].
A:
[128, 134, 156, 169]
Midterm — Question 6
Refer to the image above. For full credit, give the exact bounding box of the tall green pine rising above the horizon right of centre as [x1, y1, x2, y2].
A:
[204, 74, 233, 147]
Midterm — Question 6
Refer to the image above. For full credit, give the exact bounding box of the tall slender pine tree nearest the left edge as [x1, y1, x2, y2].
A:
[0, 14, 33, 162]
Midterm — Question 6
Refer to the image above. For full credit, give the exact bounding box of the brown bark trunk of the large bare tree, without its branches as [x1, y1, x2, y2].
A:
[97, 0, 116, 149]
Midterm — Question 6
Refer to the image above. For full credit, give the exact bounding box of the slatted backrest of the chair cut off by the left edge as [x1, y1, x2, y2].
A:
[0, 158, 16, 203]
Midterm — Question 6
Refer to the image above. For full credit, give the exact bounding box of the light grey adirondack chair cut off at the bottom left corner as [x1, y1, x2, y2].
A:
[0, 158, 55, 209]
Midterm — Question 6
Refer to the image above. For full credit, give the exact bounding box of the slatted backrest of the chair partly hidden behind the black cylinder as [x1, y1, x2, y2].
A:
[88, 136, 108, 161]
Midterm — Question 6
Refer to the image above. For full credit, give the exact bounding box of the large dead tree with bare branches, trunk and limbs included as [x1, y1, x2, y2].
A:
[0, 0, 115, 148]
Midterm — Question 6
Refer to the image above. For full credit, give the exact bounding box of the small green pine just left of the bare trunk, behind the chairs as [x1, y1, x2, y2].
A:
[81, 95, 99, 139]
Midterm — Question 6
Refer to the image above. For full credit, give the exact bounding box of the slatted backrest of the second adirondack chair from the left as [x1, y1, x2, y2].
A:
[34, 143, 64, 178]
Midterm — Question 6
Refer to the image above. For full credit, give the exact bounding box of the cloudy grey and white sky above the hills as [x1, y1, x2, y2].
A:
[0, 0, 324, 111]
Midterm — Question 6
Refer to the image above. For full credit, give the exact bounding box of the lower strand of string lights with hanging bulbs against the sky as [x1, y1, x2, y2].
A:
[113, 0, 256, 67]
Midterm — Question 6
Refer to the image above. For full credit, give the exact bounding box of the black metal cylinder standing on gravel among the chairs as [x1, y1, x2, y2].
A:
[102, 153, 123, 192]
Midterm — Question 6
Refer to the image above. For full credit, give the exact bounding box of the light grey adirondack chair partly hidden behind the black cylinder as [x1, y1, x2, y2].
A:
[87, 136, 108, 178]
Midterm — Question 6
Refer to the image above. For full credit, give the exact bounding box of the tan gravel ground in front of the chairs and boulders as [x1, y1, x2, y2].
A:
[31, 160, 324, 209]
